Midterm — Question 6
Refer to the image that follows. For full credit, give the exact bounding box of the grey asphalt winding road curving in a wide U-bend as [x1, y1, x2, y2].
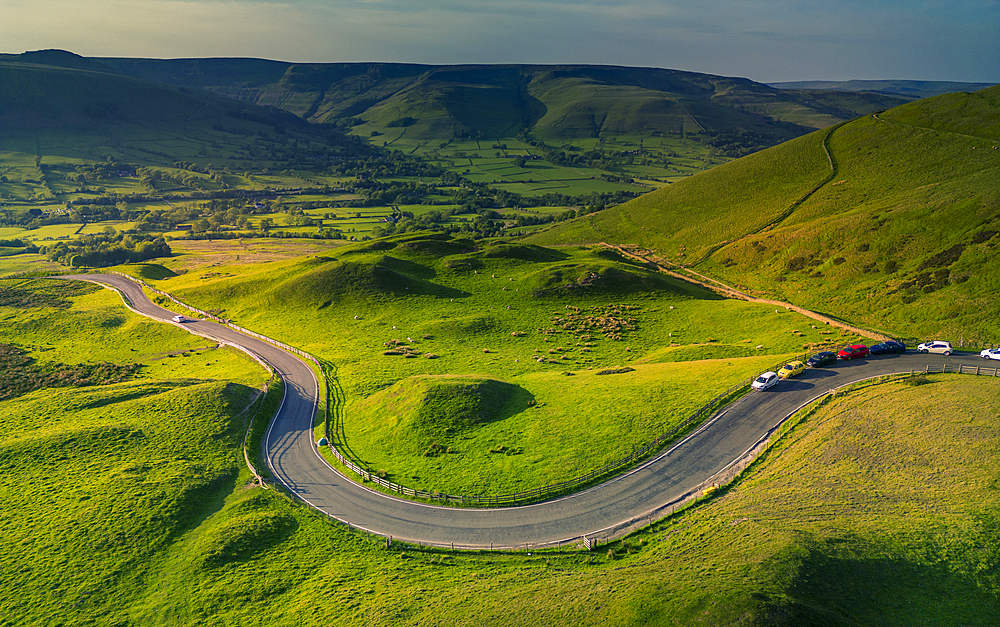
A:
[70, 275, 997, 549]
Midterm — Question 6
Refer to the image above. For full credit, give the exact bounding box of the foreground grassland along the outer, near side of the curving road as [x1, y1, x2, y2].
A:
[0, 273, 1000, 627]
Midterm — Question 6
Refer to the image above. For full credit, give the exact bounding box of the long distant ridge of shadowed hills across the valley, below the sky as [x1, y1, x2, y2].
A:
[100, 59, 899, 143]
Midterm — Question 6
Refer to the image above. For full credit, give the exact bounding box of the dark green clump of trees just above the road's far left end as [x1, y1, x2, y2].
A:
[39, 232, 171, 268]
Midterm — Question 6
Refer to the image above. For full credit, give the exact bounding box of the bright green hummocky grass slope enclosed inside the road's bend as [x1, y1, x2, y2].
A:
[143, 234, 850, 493]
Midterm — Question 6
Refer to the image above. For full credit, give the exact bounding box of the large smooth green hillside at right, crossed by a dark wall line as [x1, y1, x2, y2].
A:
[527, 87, 1000, 341]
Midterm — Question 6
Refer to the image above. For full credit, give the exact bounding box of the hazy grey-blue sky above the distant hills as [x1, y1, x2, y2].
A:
[0, 0, 1000, 83]
